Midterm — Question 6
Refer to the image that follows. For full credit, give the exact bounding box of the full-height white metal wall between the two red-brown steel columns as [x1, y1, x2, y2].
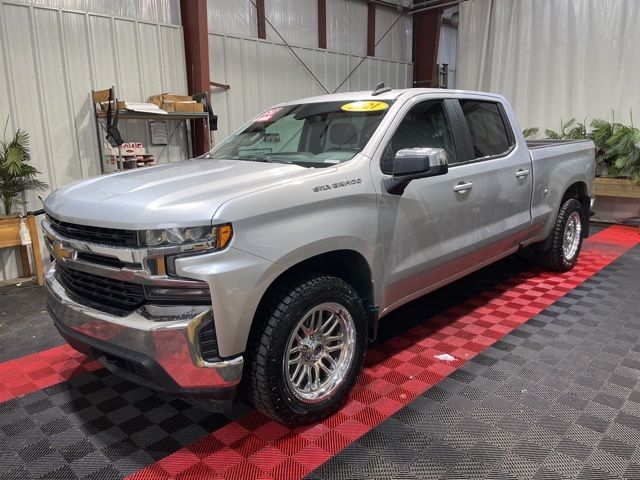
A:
[207, 0, 413, 141]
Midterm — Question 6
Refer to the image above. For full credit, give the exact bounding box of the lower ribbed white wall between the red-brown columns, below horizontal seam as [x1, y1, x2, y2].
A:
[209, 34, 413, 142]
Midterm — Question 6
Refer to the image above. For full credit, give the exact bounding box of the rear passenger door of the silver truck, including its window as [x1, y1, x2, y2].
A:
[453, 98, 533, 263]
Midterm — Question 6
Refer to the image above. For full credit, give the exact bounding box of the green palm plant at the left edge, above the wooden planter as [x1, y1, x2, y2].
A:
[0, 119, 49, 215]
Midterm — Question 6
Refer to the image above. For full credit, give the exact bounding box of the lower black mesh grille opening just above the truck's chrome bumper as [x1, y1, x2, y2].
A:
[56, 264, 145, 315]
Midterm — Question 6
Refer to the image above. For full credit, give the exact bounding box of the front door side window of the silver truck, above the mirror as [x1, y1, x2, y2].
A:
[380, 100, 455, 174]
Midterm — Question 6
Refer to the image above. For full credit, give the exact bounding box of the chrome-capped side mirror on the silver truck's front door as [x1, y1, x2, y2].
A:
[384, 148, 449, 195]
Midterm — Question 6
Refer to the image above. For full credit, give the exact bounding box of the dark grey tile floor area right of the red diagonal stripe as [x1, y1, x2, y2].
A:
[310, 247, 640, 480]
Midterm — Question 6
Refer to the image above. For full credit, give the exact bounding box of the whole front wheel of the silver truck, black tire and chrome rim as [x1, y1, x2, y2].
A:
[245, 275, 367, 425]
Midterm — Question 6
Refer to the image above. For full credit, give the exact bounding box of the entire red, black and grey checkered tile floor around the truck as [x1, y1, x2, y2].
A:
[0, 226, 640, 479]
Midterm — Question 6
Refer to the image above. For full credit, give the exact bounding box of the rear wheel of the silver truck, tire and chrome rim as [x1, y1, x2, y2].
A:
[536, 198, 584, 272]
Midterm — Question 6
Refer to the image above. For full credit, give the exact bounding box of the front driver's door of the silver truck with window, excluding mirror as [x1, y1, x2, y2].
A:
[370, 97, 479, 313]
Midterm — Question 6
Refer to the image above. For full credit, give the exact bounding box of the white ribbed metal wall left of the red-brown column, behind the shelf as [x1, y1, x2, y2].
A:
[0, 0, 187, 280]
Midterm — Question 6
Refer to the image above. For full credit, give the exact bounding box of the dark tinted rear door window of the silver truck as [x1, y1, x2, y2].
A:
[460, 100, 511, 158]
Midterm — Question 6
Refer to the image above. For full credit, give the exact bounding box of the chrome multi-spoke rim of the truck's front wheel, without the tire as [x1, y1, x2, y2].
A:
[283, 302, 356, 403]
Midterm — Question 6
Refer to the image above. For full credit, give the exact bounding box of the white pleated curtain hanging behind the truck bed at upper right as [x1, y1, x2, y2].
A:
[457, 0, 640, 130]
